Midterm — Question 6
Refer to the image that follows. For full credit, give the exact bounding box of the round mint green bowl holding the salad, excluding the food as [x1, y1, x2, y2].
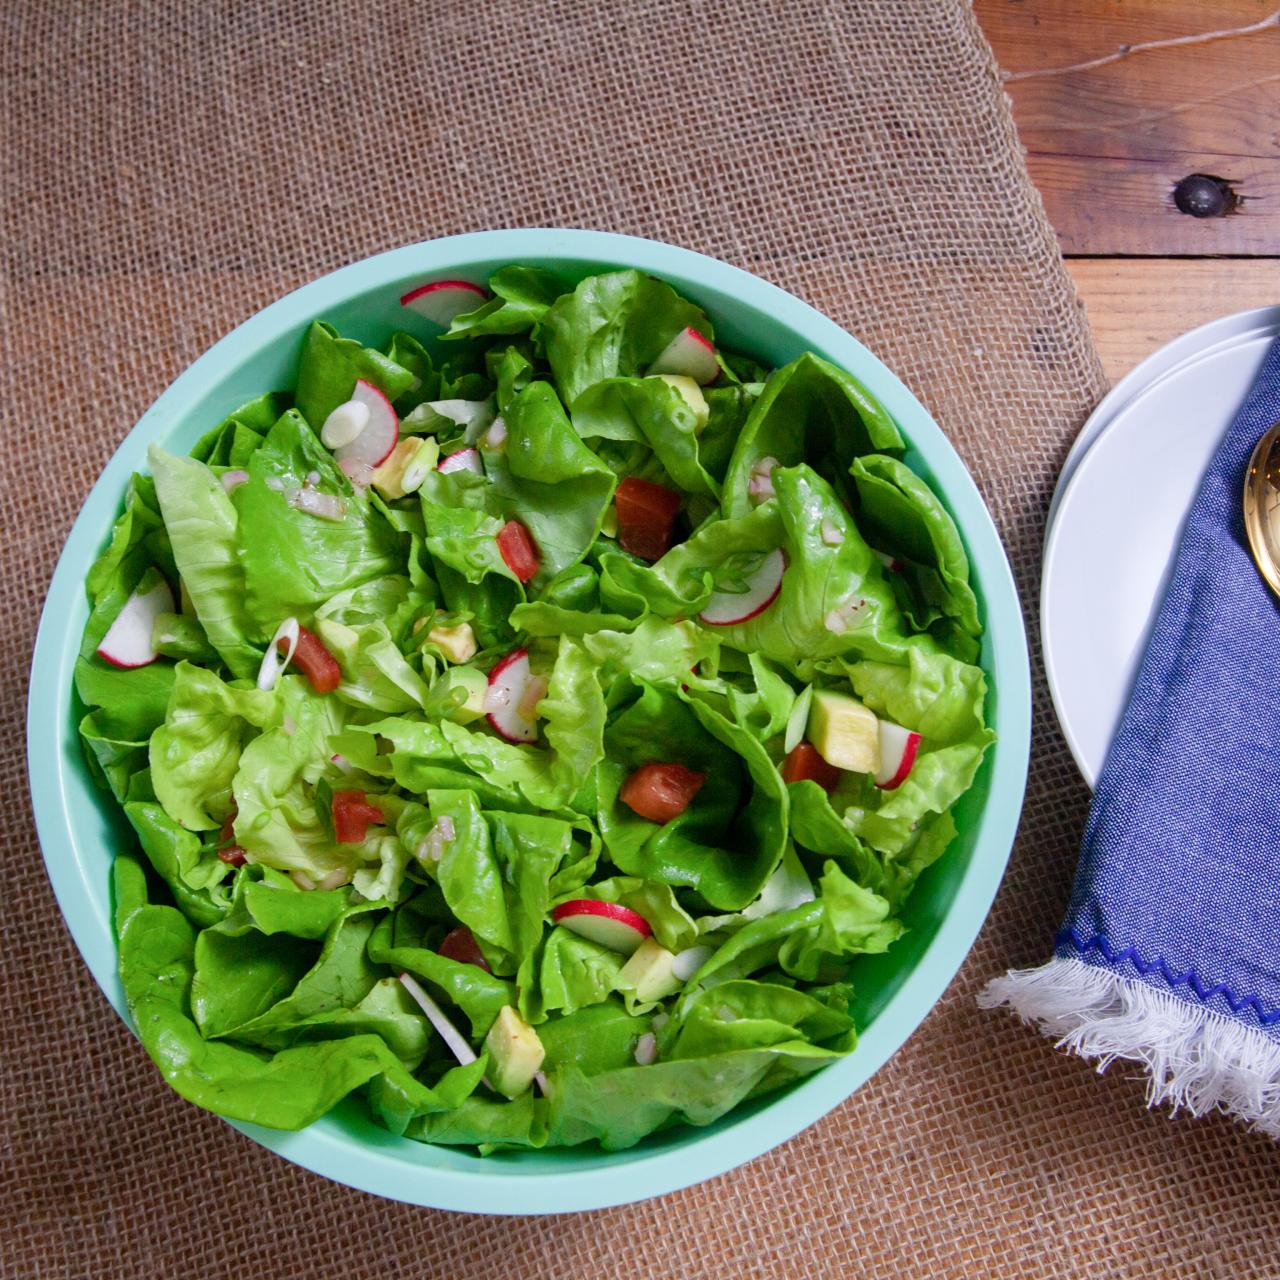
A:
[27, 230, 1030, 1213]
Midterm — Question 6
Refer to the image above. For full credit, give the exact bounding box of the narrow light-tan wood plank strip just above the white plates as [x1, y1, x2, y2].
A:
[1066, 257, 1280, 381]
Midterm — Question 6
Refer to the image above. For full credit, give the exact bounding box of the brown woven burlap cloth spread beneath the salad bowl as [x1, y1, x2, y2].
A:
[0, 0, 1280, 1280]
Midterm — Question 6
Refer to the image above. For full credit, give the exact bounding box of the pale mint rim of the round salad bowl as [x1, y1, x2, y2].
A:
[27, 228, 1030, 1213]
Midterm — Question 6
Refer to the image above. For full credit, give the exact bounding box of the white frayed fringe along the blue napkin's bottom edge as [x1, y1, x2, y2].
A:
[978, 956, 1280, 1138]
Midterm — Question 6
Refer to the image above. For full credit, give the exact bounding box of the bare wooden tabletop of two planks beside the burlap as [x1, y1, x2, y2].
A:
[974, 0, 1280, 380]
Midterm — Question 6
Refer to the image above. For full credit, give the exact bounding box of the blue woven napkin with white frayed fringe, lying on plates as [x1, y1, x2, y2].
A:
[980, 343, 1280, 1135]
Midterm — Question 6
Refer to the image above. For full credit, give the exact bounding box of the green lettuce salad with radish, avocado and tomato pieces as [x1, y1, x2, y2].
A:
[76, 266, 992, 1152]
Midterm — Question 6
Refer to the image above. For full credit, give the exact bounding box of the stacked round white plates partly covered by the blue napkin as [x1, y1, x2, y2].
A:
[1041, 306, 1280, 787]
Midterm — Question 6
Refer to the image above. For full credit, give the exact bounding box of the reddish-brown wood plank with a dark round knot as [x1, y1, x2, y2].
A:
[975, 0, 1280, 256]
